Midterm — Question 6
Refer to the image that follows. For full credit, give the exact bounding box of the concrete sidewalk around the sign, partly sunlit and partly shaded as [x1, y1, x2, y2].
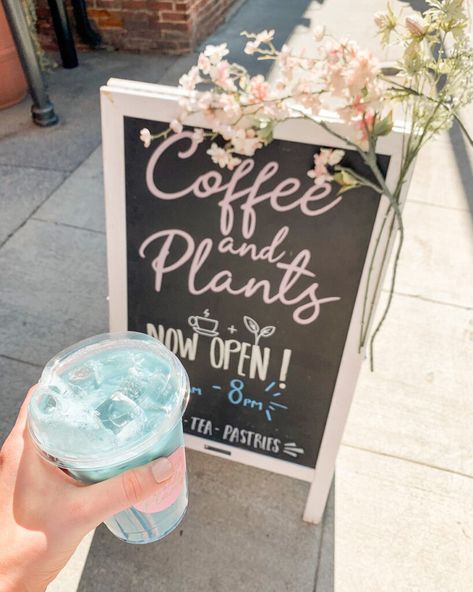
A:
[0, 0, 473, 592]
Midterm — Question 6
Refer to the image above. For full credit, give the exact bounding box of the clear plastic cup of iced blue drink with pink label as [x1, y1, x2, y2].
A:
[28, 331, 189, 543]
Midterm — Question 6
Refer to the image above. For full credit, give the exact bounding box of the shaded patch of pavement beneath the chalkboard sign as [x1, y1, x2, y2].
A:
[77, 451, 333, 592]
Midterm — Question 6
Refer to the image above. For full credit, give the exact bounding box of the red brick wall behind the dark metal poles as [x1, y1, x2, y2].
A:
[36, 0, 236, 54]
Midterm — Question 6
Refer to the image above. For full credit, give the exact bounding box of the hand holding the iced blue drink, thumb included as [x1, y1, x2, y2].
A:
[0, 387, 173, 592]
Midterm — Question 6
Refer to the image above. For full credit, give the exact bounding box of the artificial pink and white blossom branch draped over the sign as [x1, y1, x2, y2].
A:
[141, 0, 473, 368]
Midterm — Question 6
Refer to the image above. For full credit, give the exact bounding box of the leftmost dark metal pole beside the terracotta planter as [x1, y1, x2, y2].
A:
[3, 0, 59, 127]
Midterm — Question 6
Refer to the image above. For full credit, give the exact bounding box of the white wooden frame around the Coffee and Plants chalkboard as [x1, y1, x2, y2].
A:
[101, 78, 408, 524]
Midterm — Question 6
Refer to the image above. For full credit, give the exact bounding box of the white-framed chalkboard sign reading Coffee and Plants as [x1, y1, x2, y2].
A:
[102, 81, 410, 521]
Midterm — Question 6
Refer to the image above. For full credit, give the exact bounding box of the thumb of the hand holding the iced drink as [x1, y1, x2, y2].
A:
[77, 457, 174, 528]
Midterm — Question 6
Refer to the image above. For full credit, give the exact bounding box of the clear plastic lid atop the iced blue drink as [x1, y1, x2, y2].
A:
[28, 331, 189, 469]
